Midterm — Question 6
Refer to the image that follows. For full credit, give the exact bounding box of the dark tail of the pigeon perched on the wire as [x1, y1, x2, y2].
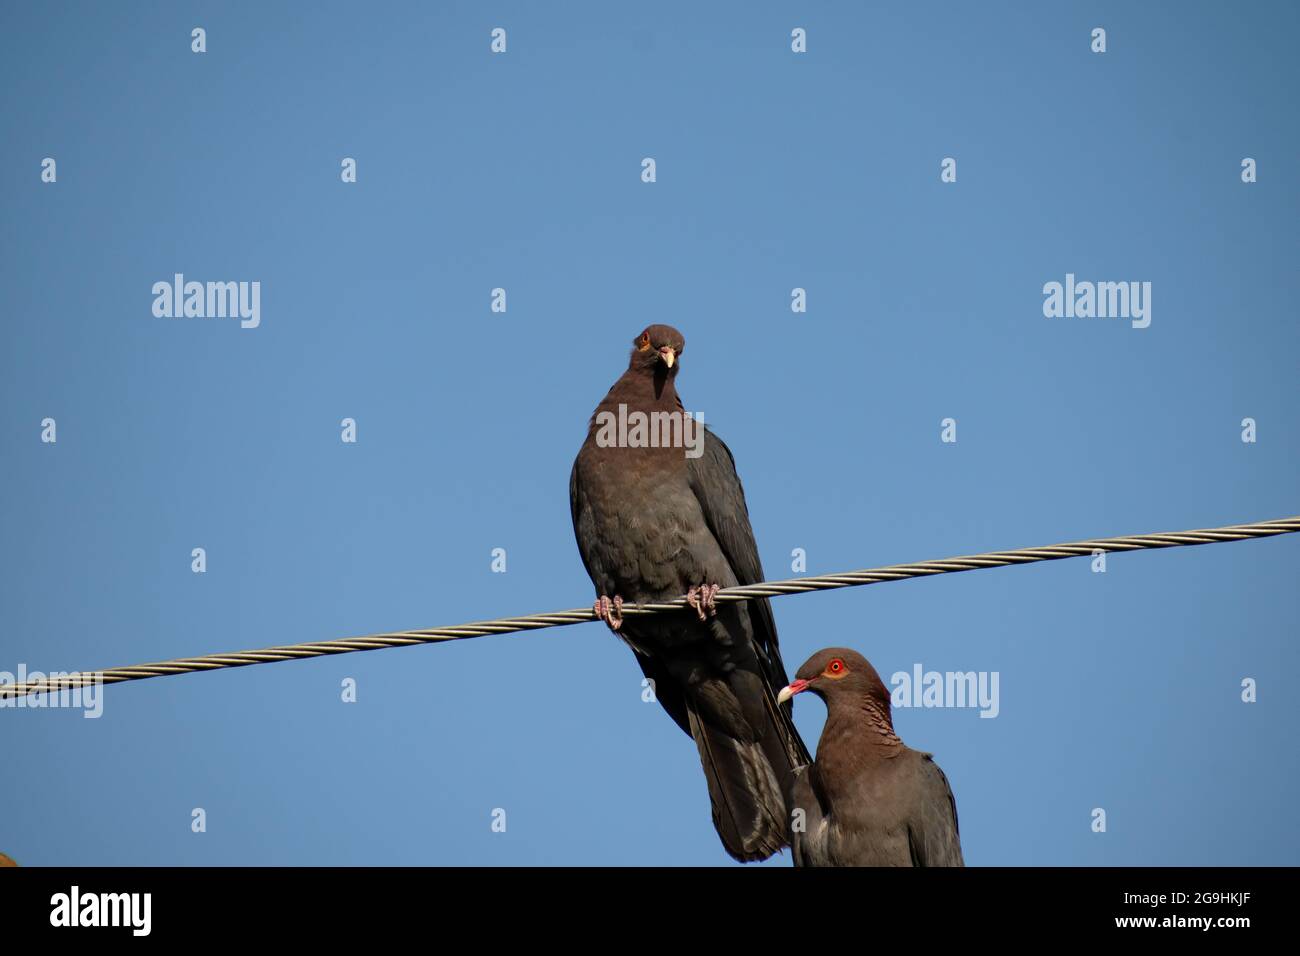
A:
[686, 682, 809, 862]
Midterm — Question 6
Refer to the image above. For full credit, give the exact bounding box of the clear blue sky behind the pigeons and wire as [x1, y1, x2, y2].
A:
[0, 3, 1300, 865]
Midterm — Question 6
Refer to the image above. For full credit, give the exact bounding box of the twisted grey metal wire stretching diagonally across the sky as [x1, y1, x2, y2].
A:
[0, 515, 1300, 698]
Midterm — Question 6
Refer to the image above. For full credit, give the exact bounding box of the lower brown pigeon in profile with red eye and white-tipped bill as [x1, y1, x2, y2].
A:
[779, 648, 965, 866]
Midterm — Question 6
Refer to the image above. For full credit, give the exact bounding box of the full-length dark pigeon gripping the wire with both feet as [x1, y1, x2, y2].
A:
[569, 325, 810, 861]
